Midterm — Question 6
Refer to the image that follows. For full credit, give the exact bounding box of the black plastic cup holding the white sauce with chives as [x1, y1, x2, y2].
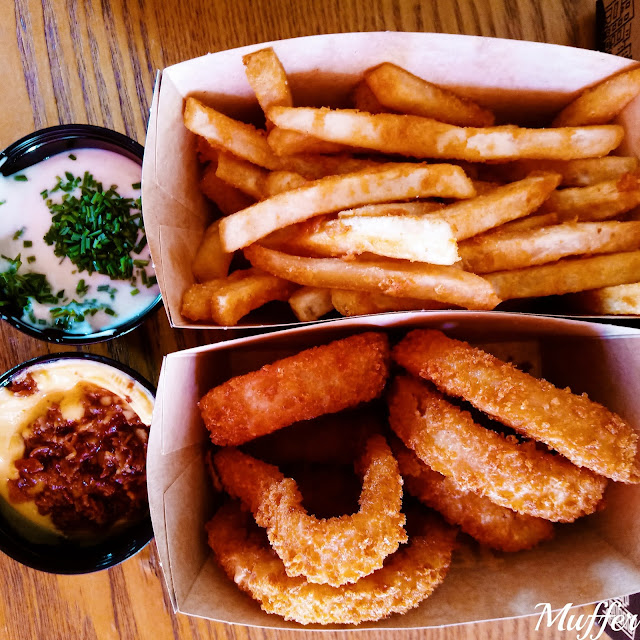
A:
[0, 124, 162, 345]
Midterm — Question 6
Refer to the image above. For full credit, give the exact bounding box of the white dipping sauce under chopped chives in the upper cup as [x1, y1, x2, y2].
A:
[0, 149, 159, 334]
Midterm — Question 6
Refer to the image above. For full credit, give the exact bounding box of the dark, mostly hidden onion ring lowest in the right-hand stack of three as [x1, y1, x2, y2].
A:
[393, 440, 553, 551]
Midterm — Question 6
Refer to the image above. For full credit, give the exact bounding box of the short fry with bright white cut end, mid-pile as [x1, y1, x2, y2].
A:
[278, 215, 459, 264]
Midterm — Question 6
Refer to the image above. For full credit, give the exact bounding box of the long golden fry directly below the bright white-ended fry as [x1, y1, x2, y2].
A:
[245, 244, 500, 309]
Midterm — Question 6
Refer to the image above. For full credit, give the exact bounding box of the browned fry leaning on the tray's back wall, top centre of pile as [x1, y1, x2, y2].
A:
[364, 62, 495, 127]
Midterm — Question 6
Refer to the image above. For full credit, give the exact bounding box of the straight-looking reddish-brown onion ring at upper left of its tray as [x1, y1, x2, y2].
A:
[199, 332, 389, 446]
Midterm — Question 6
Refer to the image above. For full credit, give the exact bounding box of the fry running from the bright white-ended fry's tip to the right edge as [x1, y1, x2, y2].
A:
[459, 222, 640, 273]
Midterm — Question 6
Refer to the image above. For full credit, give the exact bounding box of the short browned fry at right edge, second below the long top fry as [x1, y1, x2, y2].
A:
[543, 172, 640, 222]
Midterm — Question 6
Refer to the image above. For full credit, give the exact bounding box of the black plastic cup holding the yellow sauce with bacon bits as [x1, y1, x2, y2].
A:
[0, 353, 156, 574]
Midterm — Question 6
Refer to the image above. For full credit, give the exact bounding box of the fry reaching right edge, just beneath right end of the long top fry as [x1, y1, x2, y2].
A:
[481, 156, 638, 187]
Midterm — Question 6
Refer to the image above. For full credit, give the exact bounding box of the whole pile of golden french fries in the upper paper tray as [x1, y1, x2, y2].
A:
[182, 48, 640, 326]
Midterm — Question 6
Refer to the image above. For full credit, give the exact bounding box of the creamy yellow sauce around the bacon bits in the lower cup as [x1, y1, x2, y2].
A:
[0, 358, 153, 538]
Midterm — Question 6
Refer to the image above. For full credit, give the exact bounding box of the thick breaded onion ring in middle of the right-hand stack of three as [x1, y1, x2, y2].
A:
[388, 377, 607, 522]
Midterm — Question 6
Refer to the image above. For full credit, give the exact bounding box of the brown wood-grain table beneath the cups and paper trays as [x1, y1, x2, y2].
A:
[0, 0, 616, 640]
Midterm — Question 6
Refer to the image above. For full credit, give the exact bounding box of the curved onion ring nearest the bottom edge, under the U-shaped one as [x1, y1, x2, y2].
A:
[207, 504, 455, 624]
